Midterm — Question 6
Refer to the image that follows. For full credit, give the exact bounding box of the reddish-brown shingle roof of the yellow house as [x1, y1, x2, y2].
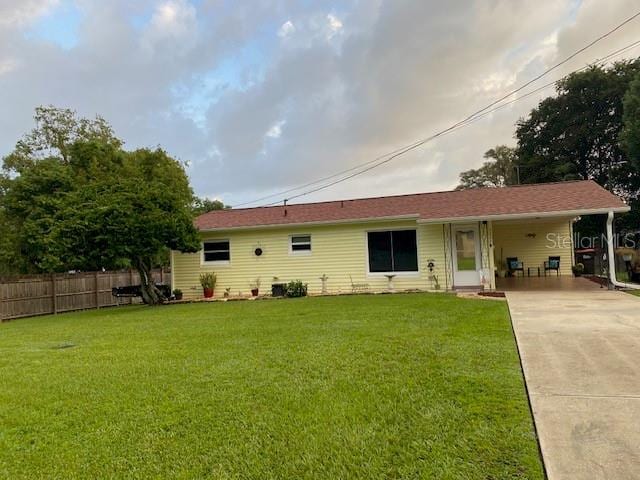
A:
[195, 180, 627, 230]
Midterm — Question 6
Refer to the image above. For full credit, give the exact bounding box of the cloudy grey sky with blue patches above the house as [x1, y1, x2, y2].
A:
[0, 0, 640, 206]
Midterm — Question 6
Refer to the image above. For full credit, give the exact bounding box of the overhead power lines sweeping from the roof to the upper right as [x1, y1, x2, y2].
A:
[235, 12, 640, 207]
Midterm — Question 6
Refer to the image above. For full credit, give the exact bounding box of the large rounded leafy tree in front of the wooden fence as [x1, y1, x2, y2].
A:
[0, 109, 199, 304]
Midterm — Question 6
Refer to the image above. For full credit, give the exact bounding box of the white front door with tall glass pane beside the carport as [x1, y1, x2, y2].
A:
[451, 224, 481, 287]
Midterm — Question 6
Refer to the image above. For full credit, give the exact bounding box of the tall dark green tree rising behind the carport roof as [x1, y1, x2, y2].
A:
[516, 59, 640, 199]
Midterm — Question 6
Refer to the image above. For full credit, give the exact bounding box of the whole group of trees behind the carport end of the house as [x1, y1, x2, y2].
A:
[458, 59, 640, 232]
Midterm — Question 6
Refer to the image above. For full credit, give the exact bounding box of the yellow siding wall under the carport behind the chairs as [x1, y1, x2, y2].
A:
[493, 218, 573, 275]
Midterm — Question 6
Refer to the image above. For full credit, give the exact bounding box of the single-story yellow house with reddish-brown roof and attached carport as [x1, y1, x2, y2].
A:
[171, 181, 629, 298]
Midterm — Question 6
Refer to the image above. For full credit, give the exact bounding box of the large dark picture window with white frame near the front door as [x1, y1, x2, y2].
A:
[367, 230, 418, 273]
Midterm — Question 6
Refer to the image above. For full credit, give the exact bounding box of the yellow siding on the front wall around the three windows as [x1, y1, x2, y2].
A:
[172, 221, 445, 298]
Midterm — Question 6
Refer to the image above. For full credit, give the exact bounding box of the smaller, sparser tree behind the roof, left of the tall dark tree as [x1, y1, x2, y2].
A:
[458, 145, 518, 190]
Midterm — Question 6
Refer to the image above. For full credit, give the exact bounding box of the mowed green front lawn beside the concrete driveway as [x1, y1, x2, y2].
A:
[0, 294, 543, 479]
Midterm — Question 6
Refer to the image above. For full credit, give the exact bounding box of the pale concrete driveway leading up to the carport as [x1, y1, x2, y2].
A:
[507, 289, 640, 480]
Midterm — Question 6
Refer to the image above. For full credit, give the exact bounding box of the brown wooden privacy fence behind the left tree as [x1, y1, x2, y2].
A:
[0, 270, 171, 322]
